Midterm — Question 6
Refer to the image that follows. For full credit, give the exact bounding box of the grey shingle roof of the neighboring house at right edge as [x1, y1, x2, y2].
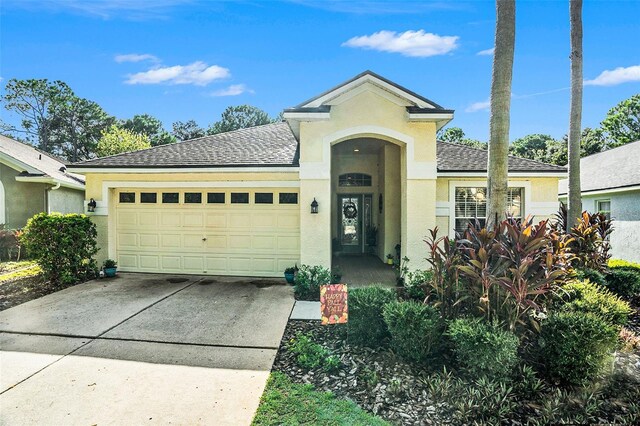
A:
[558, 141, 640, 195]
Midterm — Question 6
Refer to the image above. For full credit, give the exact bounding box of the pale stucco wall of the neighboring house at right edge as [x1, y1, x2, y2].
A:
[582, 191, 640, 262]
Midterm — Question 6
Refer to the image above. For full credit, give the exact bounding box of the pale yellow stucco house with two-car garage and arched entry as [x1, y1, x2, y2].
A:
[66, 72, 566, 276]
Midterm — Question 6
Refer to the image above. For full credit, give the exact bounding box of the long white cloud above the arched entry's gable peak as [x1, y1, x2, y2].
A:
[342, 30, 459, 57]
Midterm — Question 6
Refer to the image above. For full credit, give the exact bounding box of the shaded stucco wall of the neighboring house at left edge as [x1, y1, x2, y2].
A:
[0, 164, 51, 229]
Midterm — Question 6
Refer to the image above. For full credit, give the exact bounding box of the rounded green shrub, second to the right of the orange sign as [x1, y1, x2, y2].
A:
[383, 301, 442, 362]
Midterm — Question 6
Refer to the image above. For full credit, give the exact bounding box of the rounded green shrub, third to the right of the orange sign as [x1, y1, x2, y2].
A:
[446, 318, 519, 379]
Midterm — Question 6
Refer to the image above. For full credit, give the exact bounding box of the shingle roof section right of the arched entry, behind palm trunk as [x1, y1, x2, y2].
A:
[437, 141, 567, 173]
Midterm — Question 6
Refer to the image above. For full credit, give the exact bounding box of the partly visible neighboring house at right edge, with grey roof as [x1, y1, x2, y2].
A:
[558, 141, 640, 262]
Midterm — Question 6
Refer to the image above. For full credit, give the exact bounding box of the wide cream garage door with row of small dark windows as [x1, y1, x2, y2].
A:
[115, 188, 300, 277]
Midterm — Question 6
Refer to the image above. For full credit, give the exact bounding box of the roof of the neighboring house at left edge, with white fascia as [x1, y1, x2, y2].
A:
[0, 135, 84, 190]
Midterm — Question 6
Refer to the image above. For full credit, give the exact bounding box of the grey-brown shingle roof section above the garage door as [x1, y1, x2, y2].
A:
[73, 122, 299, 168]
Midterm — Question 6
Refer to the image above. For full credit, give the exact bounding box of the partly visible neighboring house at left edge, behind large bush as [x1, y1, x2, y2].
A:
[0, 135, 84, 229]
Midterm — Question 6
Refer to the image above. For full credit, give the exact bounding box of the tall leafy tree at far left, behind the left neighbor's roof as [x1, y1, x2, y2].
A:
[2, 78, 73, 153]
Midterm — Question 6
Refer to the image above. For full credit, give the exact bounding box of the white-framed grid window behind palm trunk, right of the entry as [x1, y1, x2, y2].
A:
[454, 187, 524, 232]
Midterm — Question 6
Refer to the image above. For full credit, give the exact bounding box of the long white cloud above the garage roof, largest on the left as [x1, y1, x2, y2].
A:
[125, 61, 231, 86]
